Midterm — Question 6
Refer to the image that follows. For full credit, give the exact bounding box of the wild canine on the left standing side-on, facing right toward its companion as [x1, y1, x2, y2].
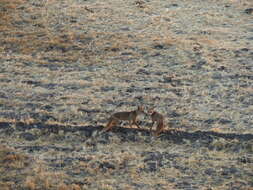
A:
[103, 106, 146, 132]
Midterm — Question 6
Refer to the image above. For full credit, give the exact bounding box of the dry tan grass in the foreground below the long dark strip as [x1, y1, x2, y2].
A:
[1, 126, 253, 189]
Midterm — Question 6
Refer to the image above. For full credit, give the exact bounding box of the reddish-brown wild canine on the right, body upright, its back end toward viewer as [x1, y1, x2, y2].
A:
[148, 108, 165, 137]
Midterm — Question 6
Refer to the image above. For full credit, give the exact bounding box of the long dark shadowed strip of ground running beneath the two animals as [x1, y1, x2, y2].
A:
[0, 122, 253, 144]
